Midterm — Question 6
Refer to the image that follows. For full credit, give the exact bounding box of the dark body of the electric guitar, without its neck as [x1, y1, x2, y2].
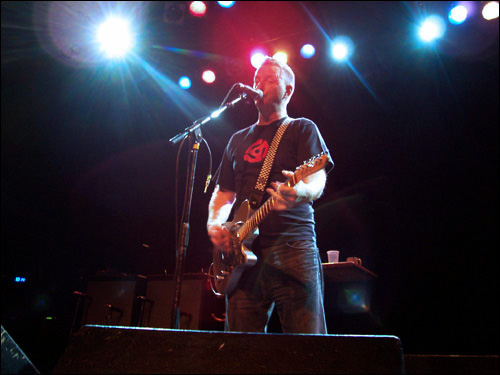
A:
[212, 199, 257, 294]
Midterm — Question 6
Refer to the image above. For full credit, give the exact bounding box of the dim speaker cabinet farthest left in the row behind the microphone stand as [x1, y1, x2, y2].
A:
[82, 275, 146, 326]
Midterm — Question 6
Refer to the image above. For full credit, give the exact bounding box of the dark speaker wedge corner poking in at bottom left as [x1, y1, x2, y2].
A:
[1, 326, 40, 374]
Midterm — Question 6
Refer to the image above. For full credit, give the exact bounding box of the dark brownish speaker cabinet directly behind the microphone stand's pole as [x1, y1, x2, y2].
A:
[142, 273, 224, 330]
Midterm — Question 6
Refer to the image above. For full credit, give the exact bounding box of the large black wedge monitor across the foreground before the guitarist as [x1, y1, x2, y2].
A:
[53, 326, 404, 374]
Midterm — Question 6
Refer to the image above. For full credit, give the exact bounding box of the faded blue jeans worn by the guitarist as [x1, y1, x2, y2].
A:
[225, 240, 327, 334]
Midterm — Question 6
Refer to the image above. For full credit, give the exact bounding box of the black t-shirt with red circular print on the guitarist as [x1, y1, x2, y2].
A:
[217, 118, 333, 246]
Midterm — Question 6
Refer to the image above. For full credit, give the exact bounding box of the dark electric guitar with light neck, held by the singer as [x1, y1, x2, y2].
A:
[209, 153, 328, 296]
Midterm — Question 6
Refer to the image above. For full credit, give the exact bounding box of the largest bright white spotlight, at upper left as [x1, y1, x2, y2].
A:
[97, 17, 135, 58]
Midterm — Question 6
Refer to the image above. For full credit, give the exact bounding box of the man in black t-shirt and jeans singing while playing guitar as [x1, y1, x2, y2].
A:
[207, 57, 333, 334]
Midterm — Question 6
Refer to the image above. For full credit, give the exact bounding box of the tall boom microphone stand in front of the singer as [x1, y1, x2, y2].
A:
[169, 92, 247, 329]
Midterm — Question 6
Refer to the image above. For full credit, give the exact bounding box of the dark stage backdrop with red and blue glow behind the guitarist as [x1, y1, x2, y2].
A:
[2, 2, 499, 374]
